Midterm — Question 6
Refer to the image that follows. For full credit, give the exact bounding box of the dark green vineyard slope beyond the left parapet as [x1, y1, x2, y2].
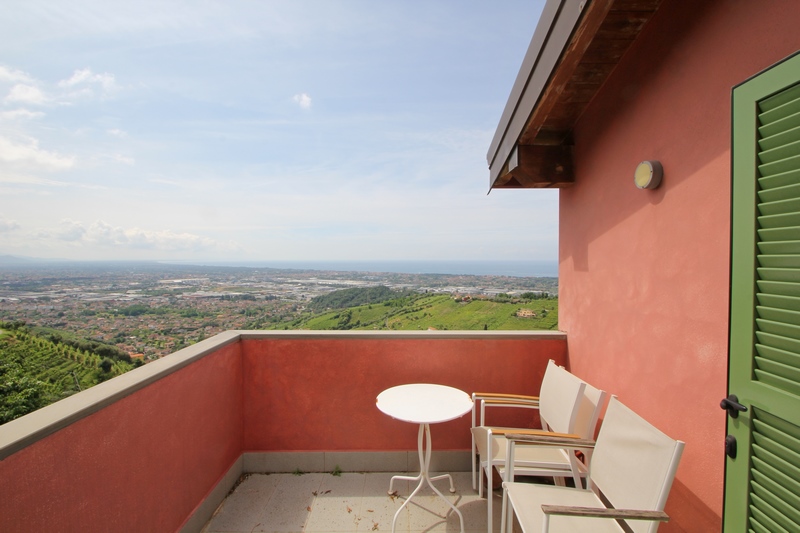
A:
[0, 323, 134, 424]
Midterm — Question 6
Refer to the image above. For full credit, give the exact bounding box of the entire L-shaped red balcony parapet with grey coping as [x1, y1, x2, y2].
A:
[0, 331, 567, 532]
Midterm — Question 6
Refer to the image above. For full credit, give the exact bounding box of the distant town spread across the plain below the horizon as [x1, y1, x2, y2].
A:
[0, 262, 558, 361]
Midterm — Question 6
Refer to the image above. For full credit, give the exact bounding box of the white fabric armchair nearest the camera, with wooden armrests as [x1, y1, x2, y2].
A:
[502, 397, 684, 533]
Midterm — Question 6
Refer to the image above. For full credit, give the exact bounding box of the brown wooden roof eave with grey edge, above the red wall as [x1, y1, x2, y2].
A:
[487, 0, 661, 189]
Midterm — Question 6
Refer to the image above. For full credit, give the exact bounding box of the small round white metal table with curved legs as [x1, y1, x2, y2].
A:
[377, 383, 472, 533]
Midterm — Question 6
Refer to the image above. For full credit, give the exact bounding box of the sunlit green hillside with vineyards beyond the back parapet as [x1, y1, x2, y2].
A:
[274, 294, 558, 330]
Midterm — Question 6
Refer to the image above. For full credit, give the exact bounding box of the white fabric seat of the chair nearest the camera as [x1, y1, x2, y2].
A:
[503, 483, 624, 533]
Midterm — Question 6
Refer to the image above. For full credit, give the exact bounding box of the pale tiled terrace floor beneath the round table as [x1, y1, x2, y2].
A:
[202, 472, 501, 533]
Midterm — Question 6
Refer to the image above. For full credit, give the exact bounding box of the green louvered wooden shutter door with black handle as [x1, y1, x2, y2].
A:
[724, 56, 800, 533]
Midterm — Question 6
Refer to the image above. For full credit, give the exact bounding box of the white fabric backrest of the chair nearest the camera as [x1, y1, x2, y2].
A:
[589, 398, 684, 532]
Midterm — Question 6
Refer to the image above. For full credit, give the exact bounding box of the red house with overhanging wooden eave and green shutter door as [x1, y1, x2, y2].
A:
[488, 0, 800, 532]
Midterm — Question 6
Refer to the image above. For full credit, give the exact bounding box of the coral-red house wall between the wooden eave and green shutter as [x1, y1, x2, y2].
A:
[559, 0, 800, 531]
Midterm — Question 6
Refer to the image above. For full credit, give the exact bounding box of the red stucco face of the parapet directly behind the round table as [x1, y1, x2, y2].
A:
[243, 338, 566, 451]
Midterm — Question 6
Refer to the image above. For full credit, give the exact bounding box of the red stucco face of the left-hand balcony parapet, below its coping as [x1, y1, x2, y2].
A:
[0, 344, 242, 533]
